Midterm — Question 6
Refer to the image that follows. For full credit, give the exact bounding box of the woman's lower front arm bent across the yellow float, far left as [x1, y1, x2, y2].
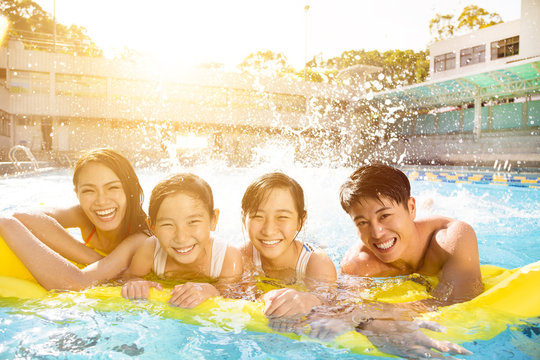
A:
[0, 217, 145, 290]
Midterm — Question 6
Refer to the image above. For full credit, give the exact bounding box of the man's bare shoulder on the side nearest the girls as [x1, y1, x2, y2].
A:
[340, 243, 383, 276]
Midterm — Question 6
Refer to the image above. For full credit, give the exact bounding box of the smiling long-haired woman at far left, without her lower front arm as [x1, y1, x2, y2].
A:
[14, 149, 149, 264]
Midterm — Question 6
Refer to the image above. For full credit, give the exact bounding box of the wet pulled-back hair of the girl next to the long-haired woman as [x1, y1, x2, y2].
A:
[148, 173, 214, 225]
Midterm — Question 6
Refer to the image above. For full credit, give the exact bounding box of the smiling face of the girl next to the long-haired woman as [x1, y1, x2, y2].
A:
[153, 193, 219, 264]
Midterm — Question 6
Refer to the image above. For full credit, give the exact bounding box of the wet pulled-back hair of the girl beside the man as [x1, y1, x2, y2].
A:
[242, 172, 307, 225]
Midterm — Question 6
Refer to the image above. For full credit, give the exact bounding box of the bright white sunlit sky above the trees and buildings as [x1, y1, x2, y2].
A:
[34, 0, 521, 69]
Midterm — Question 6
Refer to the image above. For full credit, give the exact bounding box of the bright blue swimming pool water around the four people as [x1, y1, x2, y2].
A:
[0, 163, 540, 360]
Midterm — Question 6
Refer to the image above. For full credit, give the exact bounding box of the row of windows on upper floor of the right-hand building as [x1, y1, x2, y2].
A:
[434, 35, 519, 72]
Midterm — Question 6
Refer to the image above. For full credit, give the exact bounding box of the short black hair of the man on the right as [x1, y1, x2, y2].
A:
[339, 164, 411, 213]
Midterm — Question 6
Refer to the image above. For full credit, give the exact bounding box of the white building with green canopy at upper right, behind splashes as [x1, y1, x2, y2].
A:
[376, 0, 540, 169]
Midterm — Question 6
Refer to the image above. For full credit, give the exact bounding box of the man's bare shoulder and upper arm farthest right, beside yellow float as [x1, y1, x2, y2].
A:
[431, 220, 484, 305]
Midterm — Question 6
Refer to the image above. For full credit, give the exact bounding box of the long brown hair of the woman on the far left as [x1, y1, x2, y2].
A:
[73, 149, 150, 236]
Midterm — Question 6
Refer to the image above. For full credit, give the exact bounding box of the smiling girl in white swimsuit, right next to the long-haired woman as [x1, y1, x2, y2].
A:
[122, 174, 242, 308]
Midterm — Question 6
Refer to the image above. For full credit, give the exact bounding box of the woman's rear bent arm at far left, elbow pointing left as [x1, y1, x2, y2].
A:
[13, 205, 103, 264]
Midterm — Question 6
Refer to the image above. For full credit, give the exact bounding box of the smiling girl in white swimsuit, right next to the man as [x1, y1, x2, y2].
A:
[242, 172, 336, 317]
